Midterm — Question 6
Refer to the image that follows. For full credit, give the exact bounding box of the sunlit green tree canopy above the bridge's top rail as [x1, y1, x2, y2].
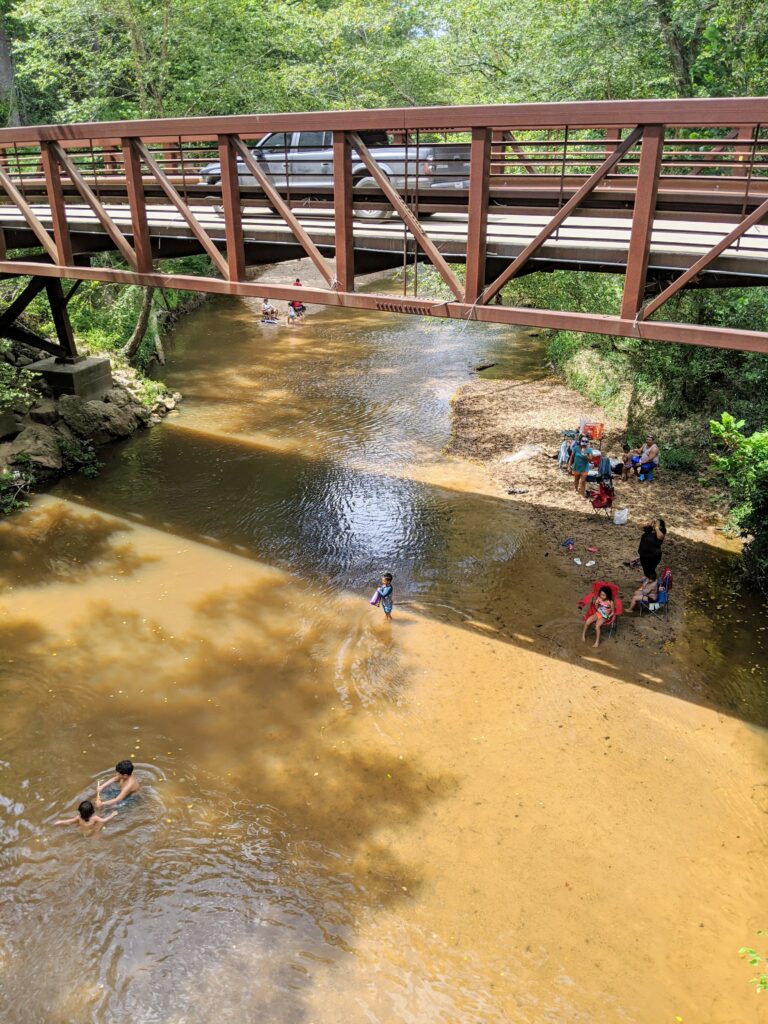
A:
[6, 0, 768, 123]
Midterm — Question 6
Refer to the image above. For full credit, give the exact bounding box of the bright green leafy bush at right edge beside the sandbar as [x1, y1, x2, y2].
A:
[710, 413, 768, 593]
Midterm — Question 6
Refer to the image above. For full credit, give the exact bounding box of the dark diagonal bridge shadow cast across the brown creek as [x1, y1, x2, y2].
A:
[41, 419, 768, 725]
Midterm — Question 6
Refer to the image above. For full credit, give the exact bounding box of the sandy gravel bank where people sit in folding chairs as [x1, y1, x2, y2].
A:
[450, 378, 734, 630]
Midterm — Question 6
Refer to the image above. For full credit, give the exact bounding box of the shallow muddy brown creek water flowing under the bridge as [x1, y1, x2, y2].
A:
[0, 286, 768, 1024]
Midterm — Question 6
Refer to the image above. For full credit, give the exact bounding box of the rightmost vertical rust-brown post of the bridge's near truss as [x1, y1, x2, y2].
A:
[622, 125, 664, 319]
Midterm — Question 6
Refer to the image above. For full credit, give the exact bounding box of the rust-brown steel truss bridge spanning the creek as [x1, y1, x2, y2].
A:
[0, 97, 768, 360]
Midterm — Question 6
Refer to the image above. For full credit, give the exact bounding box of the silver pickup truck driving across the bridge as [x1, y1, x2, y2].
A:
[200, 131, 469, 219]
